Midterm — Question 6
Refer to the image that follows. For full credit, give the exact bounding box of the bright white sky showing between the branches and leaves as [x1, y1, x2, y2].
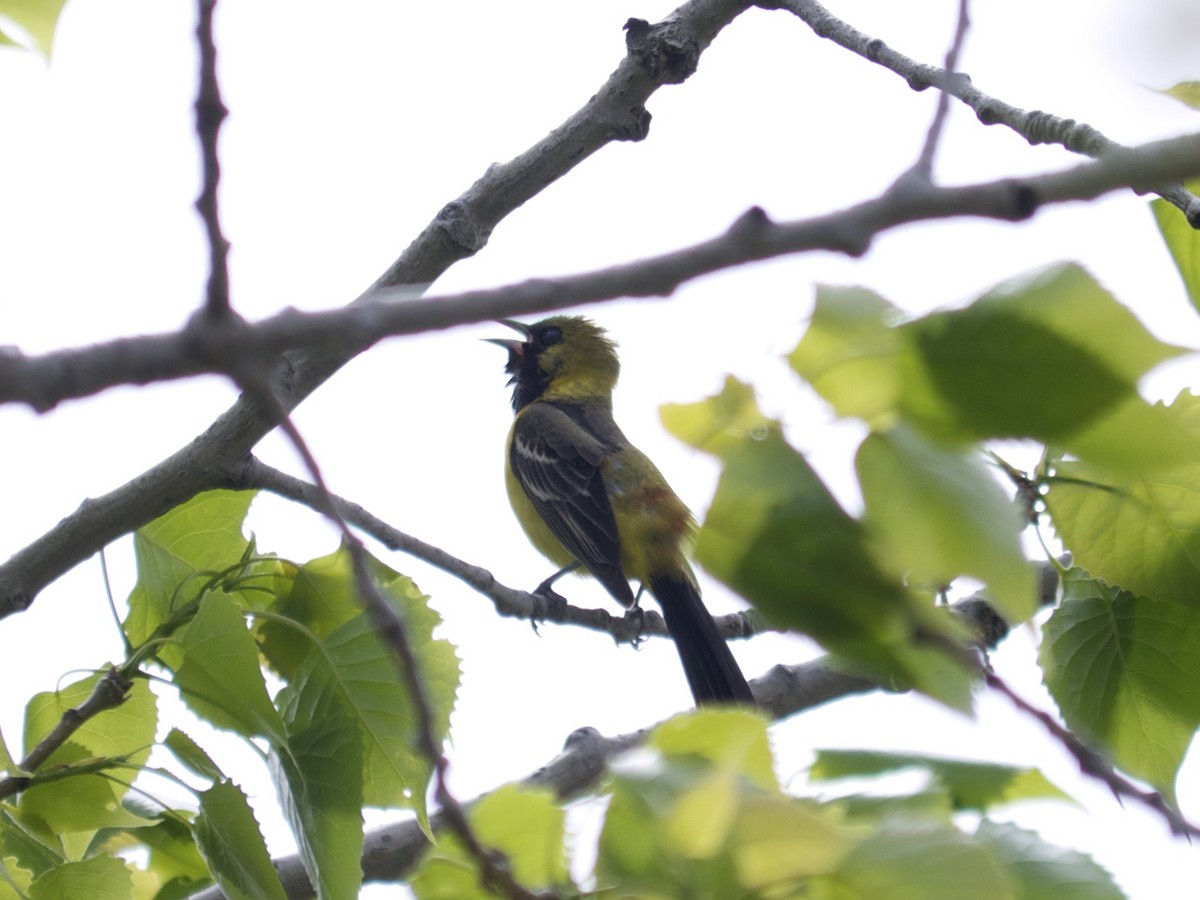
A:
[0, 0, 1200, 898]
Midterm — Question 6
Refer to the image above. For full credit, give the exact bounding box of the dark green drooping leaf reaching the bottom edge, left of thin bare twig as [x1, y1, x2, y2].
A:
[270, 682, 362, 900]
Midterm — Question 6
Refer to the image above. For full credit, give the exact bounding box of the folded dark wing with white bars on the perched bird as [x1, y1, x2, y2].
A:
[509, 403, 634, 606]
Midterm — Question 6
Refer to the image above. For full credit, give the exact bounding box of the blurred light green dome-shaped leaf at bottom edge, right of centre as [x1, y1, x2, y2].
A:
[818, 822, 1013, 900]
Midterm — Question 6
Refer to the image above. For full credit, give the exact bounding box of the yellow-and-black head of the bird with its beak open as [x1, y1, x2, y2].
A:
[492, 316, 620, 409]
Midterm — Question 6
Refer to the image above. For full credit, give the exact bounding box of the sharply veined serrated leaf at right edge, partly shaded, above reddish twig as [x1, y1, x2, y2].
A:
[1042, 568, 1200, 799]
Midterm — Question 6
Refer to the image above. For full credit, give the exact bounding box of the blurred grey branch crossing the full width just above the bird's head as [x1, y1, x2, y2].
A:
[0, 125, 1200, 422]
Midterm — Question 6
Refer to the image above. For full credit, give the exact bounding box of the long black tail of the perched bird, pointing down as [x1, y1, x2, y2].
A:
[649, 574, 754, 706]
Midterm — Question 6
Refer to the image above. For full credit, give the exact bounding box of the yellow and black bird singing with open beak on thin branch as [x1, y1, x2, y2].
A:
[487, 316, 754, 706]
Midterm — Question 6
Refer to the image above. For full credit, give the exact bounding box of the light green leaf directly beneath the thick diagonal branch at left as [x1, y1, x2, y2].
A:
[125, 491, 254, 660]
